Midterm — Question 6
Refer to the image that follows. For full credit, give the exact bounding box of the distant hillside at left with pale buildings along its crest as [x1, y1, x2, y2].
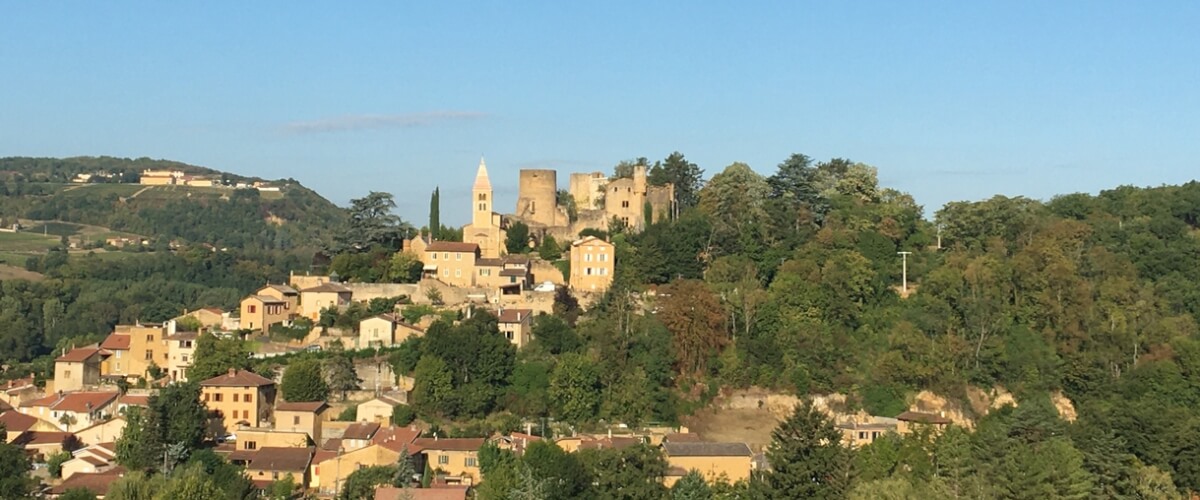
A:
[0, 157, 344, 251]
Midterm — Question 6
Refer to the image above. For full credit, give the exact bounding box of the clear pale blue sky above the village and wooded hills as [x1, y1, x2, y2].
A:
[0, 0, 1200, 225]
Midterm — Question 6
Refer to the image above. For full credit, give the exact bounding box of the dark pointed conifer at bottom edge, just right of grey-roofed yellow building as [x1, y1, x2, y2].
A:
[755, 402, 851, 499]
